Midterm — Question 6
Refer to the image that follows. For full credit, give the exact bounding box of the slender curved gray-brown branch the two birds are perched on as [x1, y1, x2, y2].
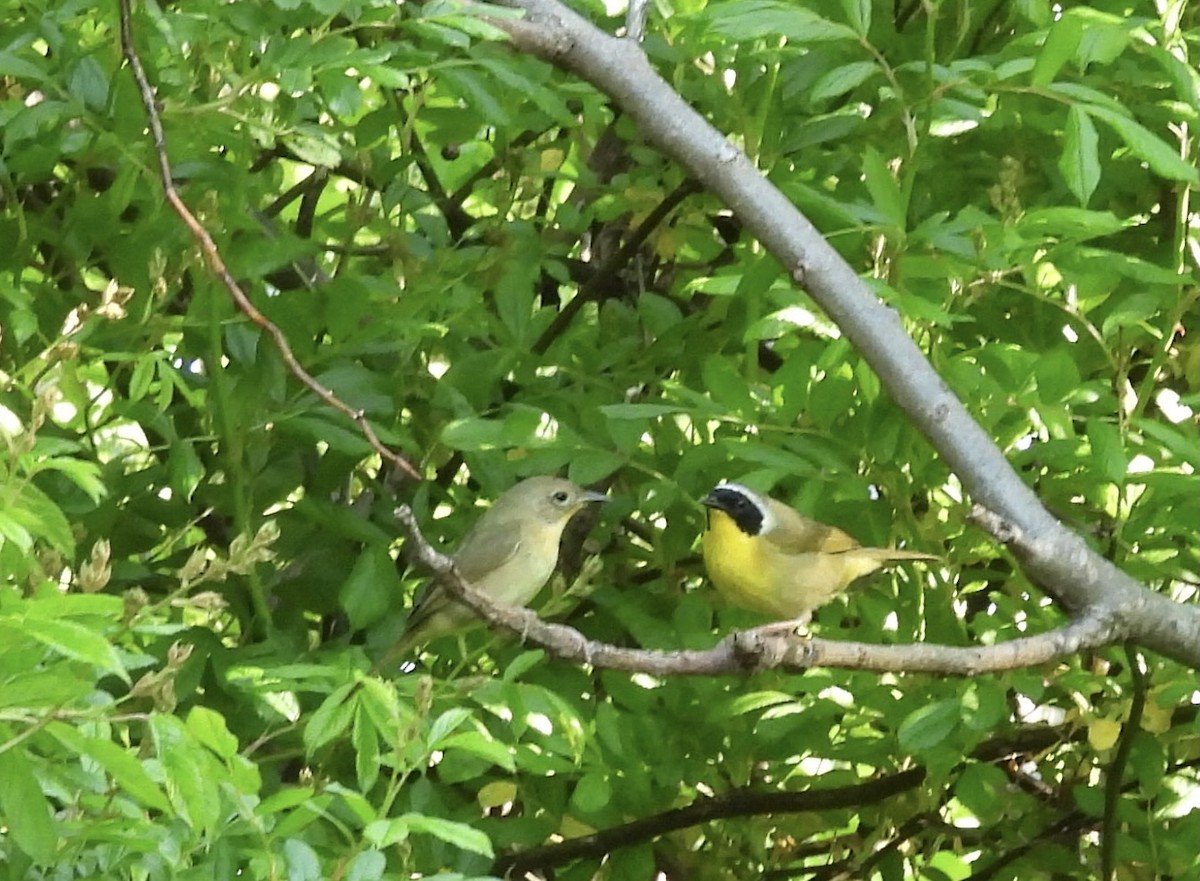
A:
[396, 505, 1112, 676]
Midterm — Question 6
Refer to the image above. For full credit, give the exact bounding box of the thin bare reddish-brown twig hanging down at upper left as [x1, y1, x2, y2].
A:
[119, 0, 421, 480]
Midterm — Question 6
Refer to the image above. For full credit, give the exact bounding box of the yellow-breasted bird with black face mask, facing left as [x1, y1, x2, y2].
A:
[701, 484, 937, 623]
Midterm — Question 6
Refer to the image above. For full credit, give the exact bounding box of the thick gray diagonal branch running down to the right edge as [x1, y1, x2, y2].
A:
[477, 0, 1200, 667]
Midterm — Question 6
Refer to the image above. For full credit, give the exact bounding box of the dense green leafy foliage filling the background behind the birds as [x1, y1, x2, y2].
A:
[0, 0, 1200, 881]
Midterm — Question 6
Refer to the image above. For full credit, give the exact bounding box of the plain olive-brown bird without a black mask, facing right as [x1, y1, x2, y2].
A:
[388, 478, 608, 658]
